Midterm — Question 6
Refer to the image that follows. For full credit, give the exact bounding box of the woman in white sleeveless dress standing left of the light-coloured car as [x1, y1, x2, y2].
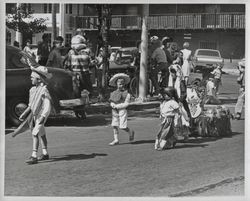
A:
[181, 42, 192, 85]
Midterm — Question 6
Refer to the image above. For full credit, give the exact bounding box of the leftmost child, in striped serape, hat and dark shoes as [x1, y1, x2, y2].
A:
[19, 63, 52, 164]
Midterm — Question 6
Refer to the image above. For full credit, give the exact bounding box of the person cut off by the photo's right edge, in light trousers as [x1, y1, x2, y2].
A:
[235, 59, 245, 120]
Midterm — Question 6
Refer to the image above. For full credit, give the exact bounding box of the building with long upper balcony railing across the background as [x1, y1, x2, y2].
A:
[6, 4, 245, 58]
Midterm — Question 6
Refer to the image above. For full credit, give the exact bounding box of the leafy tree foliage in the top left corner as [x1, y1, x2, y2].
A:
[6, 4, 47, 33]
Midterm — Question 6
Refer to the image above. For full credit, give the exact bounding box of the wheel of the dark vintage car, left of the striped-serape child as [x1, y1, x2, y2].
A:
[6, 97, 28, 126]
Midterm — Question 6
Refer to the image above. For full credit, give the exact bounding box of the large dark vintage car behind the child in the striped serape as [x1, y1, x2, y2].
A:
[6, 46, 88, 126]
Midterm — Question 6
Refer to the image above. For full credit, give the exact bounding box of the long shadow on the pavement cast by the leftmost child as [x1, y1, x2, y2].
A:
[41, 153, 107, 163]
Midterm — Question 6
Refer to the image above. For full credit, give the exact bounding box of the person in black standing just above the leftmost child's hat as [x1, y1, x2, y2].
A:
[37, 34, 50, 66]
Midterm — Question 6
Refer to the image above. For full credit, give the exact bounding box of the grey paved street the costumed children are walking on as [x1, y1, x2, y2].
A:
[4, 70, 245, 197]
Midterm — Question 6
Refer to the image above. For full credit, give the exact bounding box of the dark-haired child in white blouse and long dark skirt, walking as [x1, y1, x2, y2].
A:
[155, 87, 180, 151]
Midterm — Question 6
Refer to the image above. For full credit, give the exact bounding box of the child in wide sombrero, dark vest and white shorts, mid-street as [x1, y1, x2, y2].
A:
[109, 73, 135, 146]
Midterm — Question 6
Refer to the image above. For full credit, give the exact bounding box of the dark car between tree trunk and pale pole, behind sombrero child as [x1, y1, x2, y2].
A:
[109, 47, 138, 76]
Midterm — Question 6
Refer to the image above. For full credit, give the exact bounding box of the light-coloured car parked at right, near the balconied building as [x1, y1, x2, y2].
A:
[192, 49, 224, 72]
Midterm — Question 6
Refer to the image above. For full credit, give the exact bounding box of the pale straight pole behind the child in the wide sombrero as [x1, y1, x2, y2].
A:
[138, 4, 149, 102]
